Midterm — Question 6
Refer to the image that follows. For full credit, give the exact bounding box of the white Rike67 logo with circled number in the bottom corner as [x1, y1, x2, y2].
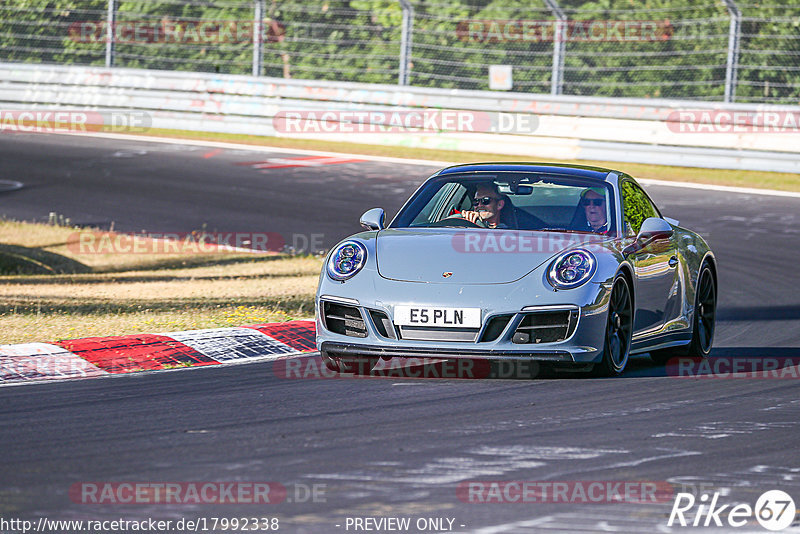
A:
[667, 490, 797, 531]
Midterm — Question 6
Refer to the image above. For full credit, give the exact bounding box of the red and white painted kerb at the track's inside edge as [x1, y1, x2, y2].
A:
[0, 320, 316, 385]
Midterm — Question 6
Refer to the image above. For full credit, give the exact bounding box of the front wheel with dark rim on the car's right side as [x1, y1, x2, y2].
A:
[592, 274, 633, 376]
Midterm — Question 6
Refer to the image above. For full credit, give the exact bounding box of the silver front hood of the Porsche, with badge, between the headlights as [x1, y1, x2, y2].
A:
[376, 228, 603, 285]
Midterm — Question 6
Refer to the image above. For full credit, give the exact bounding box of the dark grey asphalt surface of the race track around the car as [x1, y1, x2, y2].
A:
[0, 134, 800, 533]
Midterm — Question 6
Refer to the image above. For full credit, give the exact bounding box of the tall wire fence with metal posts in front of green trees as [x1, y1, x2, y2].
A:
[0, 0, 800, 104]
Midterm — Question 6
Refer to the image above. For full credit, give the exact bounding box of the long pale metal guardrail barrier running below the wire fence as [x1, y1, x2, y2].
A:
[0, 63, 800, 172]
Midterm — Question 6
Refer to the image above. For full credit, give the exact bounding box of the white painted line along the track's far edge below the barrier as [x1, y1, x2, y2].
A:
[50, 132, 800, 198]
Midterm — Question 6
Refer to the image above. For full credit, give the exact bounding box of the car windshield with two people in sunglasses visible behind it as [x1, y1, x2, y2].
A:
[390, 173, 616, 234]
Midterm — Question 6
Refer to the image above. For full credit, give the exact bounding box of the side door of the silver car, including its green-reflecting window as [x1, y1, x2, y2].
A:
[621, 180, 678, 334]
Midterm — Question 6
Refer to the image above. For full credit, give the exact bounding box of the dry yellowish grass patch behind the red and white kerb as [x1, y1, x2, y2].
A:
[0, 221, 322, 344]
